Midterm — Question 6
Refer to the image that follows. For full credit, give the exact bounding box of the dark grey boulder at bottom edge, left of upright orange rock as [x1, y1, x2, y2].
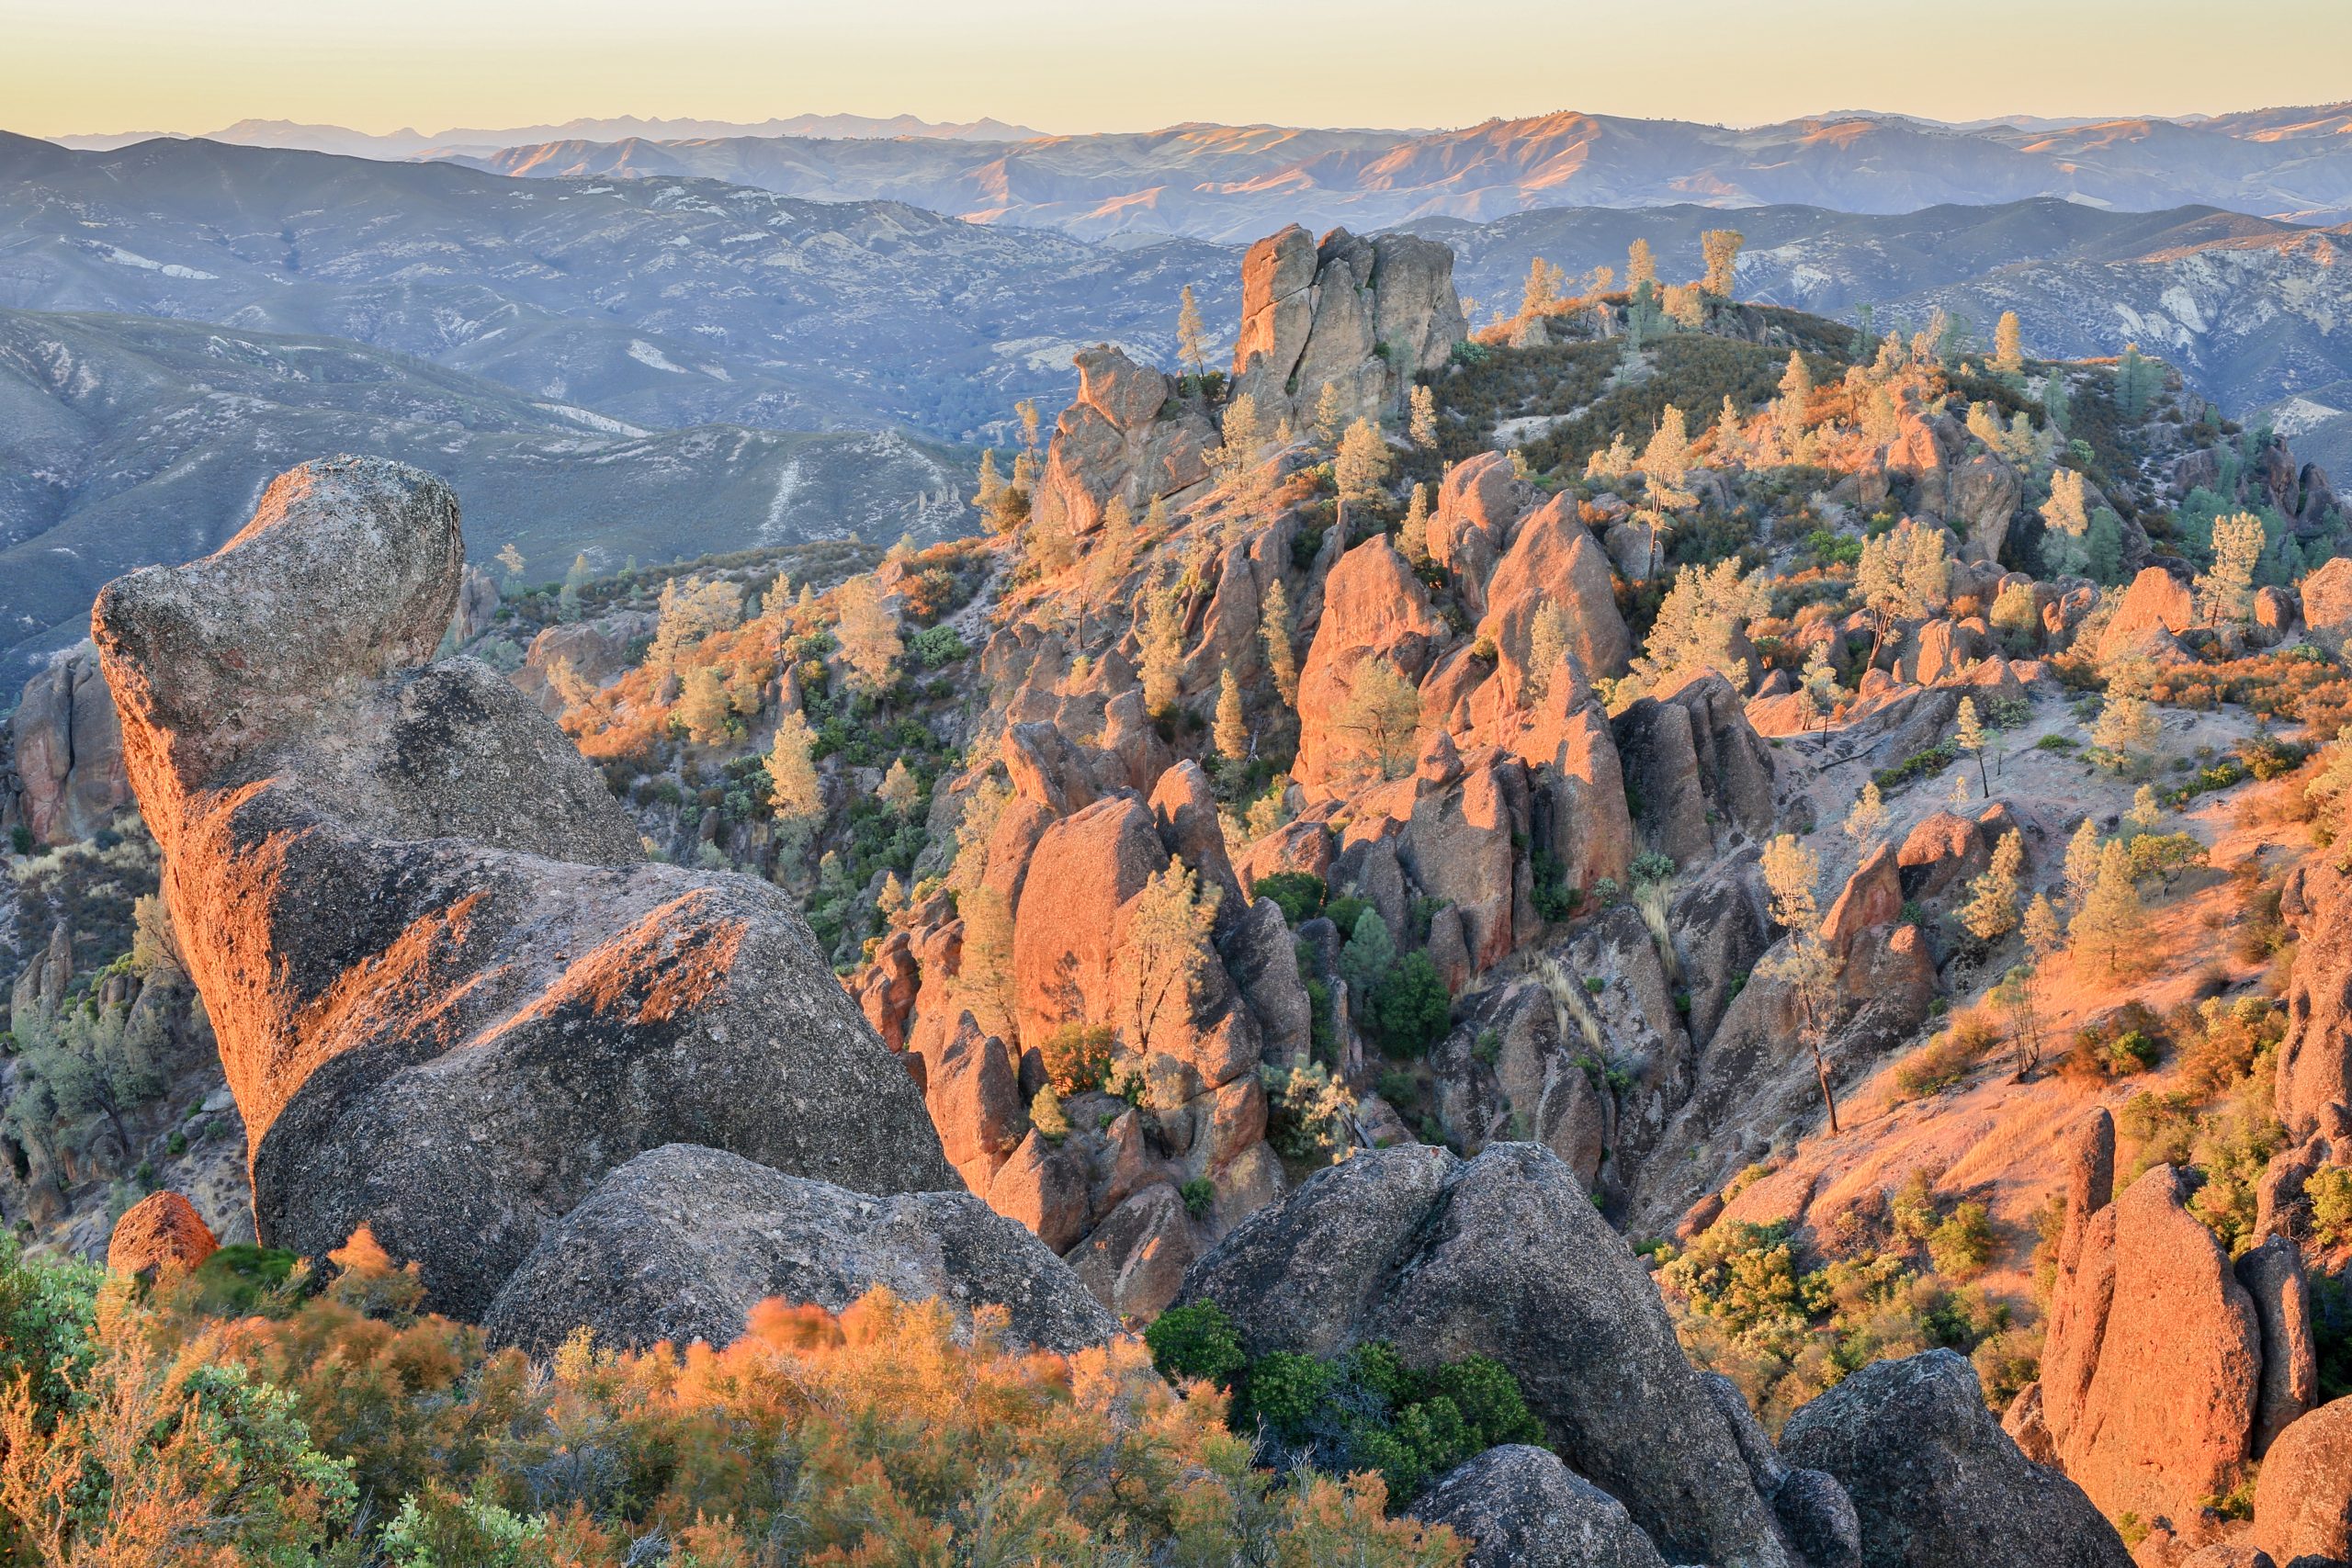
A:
[1781, 1349, 2131, 1568]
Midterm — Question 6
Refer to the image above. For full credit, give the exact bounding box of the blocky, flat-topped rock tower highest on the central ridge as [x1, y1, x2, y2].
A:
[1232, 223, 1467, 428]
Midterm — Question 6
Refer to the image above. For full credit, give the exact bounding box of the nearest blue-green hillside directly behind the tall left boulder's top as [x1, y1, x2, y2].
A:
[0, 310, 971, 667]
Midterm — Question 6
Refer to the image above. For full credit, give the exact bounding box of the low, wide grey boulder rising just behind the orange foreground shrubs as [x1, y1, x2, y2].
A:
[482, 1143, 1117, 1357]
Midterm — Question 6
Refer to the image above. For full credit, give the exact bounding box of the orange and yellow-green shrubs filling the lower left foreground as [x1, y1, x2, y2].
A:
[0, 1239, 1463, 1568]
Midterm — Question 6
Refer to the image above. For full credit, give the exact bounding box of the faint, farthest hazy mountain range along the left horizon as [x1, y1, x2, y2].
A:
[51, 115, 1040, 157]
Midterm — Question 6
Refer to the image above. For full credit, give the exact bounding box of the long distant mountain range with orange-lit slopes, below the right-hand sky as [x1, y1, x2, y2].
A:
[427, 106, 2352, 243]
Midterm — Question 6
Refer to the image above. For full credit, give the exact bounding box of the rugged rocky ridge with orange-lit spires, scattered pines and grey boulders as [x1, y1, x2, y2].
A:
[0, 231, 2352, 1565]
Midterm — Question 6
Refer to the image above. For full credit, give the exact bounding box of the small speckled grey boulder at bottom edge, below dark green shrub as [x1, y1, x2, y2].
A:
[1414, 1443, 1665, 1568]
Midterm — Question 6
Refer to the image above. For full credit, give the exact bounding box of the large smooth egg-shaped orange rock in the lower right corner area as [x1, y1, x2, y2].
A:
[2041, 1161, 2263, 1523]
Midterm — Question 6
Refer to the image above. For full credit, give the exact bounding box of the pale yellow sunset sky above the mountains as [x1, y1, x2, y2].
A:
[14, 0, 2352, 136]
